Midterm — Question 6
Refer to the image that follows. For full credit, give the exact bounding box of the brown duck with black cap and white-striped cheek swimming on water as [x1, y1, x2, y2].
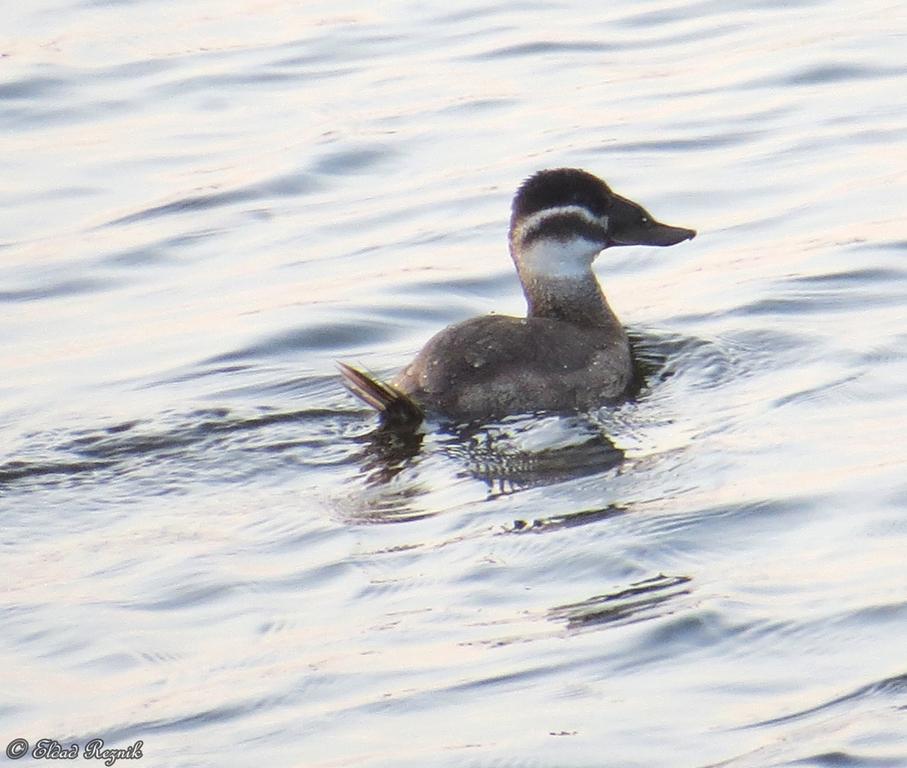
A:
[340, 168, 696, 423]
